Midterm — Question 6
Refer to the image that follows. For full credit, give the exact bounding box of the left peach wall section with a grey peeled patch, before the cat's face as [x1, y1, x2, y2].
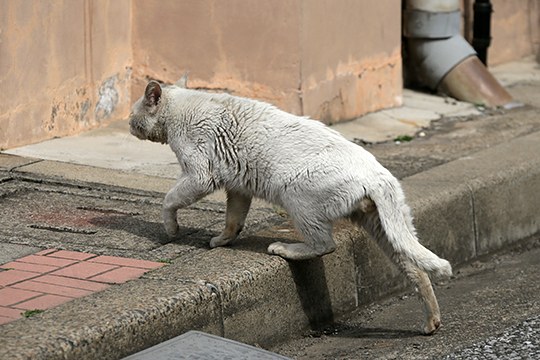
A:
[0, 0, 131, 148]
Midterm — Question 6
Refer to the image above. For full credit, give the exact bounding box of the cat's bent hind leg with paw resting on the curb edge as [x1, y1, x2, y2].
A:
[268, 220, 336, 260]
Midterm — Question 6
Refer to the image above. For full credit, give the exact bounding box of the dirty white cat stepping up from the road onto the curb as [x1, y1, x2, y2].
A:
[130, 78, 452, 334]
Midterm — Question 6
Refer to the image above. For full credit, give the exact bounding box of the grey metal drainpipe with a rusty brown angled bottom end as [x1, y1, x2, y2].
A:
[403, 0, 513, 107]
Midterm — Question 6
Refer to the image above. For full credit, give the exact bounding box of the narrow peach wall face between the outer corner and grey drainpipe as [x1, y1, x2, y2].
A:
[300, 0, 402, 122]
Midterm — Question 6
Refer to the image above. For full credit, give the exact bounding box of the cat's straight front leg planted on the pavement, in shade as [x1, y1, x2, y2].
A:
[210, 191, 252, 248]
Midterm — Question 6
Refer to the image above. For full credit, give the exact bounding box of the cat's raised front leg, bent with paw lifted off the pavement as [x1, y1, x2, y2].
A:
[163, 176, 213, 237]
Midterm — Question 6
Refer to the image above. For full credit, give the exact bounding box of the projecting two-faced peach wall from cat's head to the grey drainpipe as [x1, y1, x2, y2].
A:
[133, 0, 401, 122]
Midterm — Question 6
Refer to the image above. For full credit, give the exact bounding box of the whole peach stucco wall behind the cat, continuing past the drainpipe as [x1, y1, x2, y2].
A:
[0, 0, 540, 151]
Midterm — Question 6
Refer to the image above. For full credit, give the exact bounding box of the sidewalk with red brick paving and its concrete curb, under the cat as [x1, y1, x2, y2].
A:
[0, 57, 540, 359]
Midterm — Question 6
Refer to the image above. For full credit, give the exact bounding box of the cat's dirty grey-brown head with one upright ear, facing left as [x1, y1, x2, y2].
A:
[129, 80, 167, 143]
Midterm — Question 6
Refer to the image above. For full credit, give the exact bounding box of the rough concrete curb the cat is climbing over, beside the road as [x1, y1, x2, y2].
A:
[0, 132, 540, 359]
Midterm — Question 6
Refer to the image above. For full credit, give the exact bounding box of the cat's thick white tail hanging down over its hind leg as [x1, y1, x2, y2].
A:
[359, 177, 452, 277]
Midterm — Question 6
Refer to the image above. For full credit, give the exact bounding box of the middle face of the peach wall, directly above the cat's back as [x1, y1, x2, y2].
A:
[129, 0, 301, 113]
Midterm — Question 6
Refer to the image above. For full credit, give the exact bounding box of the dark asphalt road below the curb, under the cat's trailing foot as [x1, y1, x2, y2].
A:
[272, 235, 540, 359]
